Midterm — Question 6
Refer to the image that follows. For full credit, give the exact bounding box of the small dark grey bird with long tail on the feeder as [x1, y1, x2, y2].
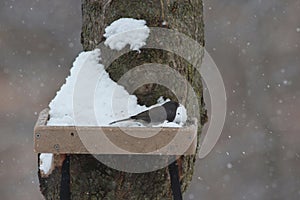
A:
[109, 101, 179, 125]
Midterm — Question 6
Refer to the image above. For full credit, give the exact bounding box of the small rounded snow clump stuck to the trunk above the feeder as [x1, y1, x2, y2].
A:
[104, 18, 150, 51]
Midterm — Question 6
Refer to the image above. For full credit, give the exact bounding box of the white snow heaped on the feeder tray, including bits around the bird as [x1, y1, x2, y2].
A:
[47, 49, 186, 127]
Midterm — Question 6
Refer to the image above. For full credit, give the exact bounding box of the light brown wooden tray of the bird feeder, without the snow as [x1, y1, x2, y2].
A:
[34, 108, 198, 155]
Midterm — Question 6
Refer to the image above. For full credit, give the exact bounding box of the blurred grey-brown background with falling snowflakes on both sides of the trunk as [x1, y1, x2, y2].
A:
[0, 0, 300, 200]
